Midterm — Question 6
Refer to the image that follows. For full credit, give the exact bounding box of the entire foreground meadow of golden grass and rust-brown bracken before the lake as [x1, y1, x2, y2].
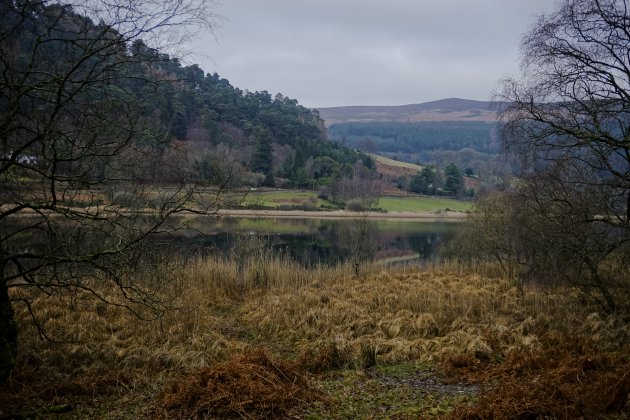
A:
[0, 253, 630, 419]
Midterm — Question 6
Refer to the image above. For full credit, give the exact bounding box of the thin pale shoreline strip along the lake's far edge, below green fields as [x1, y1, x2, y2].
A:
[217, 209, 468, 220]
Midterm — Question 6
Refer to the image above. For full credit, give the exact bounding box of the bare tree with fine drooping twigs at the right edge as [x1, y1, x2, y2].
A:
[496, 0, 630, 311]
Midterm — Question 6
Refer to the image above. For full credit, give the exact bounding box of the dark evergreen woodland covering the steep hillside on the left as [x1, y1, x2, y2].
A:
[0, 2, 374, 187]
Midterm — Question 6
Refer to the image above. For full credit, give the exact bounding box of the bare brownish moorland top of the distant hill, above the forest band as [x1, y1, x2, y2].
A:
[318, 98, 497, 127]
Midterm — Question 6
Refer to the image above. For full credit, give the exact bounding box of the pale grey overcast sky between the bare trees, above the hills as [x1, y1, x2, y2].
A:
[189, 0, 553, 107]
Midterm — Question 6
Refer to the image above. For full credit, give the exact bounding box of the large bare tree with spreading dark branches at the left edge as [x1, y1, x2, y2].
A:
[0, 0, 220, 380]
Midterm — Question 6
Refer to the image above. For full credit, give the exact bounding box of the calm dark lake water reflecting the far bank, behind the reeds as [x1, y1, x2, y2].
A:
[169, 218, 460, 265]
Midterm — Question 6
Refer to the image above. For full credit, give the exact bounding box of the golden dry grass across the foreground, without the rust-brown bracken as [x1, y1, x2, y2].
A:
[0, 257, 630, 417]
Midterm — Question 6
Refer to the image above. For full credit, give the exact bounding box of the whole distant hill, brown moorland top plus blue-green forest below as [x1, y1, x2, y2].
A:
[318, 98, 500, 174]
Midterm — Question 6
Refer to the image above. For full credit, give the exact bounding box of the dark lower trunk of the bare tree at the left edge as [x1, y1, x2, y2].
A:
[0, 270, 17, 384]
